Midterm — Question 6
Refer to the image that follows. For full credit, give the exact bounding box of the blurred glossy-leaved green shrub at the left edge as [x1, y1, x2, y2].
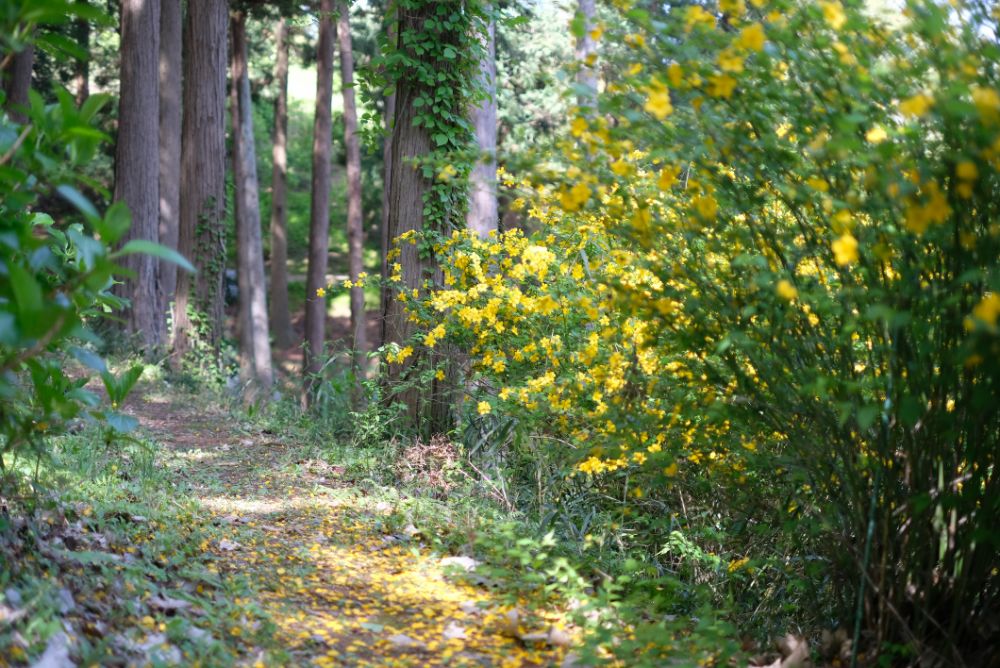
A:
[0, 0, 192, 478]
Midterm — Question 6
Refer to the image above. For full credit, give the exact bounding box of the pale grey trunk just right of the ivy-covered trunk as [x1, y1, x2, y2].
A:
[465, 10, 498, 237]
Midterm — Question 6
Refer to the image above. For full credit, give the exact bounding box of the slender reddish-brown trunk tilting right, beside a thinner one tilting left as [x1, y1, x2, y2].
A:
[303, 0, 334, 401]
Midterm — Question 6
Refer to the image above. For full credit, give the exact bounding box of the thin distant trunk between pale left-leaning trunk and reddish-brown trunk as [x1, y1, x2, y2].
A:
[271, 18, 292, 349]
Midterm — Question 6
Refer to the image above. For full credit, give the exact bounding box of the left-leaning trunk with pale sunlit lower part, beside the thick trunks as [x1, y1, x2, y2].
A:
[231, 11, 274, 401]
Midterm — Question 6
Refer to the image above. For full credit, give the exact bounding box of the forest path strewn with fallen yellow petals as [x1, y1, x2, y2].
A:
[130, 393, 565, 666]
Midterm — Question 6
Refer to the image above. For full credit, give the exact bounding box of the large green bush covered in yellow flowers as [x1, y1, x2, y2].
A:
[390, 0, 1000, 661]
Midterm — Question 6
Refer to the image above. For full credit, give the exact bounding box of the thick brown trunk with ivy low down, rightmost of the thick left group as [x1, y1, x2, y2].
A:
[174, 0, 228, 360]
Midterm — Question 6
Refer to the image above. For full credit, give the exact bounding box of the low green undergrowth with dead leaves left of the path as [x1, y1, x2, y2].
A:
[0, 428, 282, 666]
